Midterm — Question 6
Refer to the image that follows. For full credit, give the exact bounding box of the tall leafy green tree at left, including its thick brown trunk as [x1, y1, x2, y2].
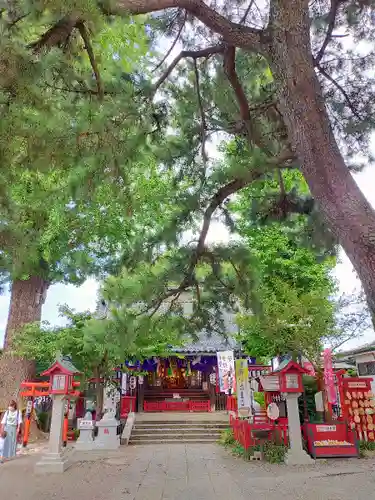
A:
[0, 6, 176, 402]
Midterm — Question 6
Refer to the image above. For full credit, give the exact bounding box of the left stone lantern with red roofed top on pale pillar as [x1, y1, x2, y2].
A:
[35, 356, 80, 473]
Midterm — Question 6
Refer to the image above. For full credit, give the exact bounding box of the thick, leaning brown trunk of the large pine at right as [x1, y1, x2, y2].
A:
[270, 0, 375, 312]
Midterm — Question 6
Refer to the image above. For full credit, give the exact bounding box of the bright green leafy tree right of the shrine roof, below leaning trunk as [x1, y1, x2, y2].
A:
[232, 173, 338, 363]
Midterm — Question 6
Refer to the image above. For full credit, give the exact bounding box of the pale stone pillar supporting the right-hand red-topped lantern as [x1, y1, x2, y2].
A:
[285, 393, 314, 465]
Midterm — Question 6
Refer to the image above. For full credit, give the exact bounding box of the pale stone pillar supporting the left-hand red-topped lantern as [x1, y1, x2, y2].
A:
[35, 394, 70, 473]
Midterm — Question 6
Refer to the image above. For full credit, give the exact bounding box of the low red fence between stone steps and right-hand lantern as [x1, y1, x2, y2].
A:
[230, 415, 289, 450]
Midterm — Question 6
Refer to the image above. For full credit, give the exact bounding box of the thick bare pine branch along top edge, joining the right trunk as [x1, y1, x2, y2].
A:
[114, 0, 268, 53]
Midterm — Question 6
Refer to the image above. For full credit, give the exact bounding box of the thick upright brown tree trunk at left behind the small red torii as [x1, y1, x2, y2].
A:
[0, 276, 49, 409]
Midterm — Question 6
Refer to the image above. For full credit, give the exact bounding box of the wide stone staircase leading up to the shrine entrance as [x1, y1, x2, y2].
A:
[129, 417, 229, 445]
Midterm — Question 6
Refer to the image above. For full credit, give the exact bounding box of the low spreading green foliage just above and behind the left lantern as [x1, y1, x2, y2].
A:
[14, 302, 182, 378]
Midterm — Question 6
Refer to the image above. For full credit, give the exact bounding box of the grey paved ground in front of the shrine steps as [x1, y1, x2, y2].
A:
[0, 444, 375, 500]
